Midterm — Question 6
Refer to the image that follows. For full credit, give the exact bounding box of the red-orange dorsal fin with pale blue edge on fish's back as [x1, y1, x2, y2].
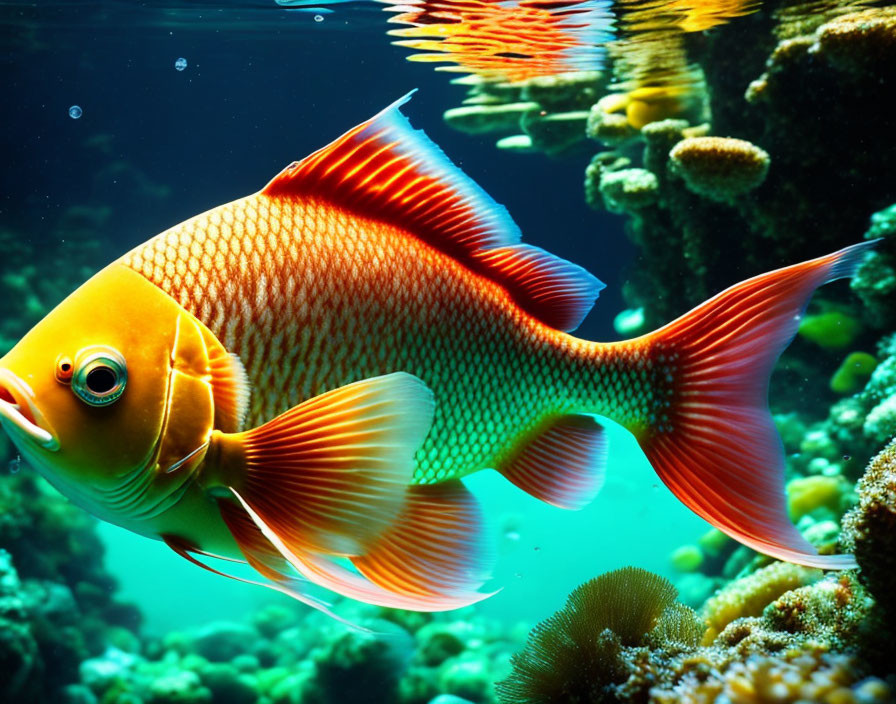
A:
[262, 94, 604, 330]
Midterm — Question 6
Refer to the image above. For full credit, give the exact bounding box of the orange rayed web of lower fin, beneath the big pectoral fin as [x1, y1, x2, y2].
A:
[352, 481, 492, 597]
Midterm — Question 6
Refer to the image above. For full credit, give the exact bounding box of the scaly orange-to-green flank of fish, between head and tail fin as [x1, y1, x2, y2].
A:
[124, 194, 655, 484]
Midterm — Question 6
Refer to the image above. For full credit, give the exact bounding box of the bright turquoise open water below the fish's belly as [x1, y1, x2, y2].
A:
[100, 425, 709, 634]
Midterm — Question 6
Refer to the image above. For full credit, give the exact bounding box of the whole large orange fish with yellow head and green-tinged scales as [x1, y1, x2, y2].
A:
[0, 95, 875, 611]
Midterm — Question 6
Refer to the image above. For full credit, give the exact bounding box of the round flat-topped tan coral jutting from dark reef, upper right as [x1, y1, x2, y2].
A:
[669, 137, 769, 202]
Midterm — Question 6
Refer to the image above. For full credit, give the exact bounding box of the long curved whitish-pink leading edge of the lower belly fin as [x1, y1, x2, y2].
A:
[231, 489, 491, 611]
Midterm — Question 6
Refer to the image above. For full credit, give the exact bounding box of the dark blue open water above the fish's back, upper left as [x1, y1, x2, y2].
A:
[0, 0, 632, 339]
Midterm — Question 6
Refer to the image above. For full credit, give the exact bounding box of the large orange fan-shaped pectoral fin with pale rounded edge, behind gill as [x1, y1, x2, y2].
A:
[208, 372, 433, 555]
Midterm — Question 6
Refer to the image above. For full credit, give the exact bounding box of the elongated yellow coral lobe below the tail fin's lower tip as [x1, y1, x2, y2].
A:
[701, 562, 822, 645]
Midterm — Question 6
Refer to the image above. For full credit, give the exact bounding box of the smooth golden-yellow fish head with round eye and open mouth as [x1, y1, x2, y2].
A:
[0, 263, 214, 522]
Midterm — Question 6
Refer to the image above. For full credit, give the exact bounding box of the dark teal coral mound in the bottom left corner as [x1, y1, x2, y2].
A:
[0, 471, 140, 704]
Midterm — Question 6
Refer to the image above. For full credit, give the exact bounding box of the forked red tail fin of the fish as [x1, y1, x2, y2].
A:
[639, 242, 875, 569]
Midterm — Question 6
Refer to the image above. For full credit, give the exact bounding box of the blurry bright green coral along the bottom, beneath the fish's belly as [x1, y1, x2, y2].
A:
[81, 604, 516, 704]
